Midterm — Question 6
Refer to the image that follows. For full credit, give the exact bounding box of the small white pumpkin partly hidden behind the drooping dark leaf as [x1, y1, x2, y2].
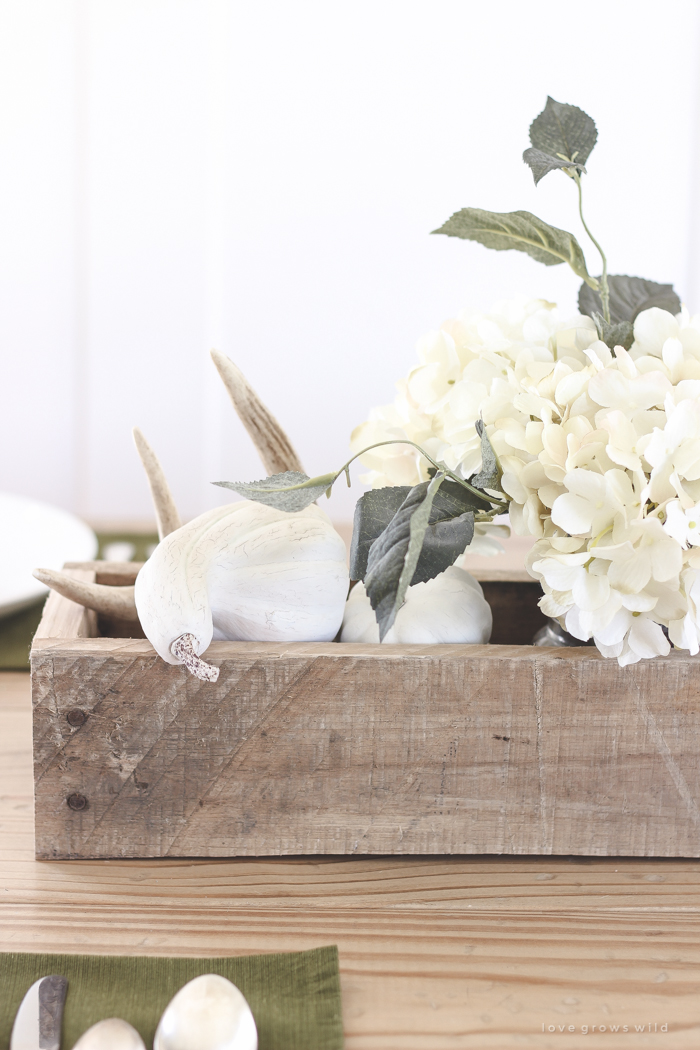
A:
[340, 565, 493, 645]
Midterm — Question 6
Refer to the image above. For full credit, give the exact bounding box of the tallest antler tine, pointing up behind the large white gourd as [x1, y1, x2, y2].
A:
[211, 350, 303, 475]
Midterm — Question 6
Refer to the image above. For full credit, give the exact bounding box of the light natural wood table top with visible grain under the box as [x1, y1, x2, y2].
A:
[0, 673, 700, 1050]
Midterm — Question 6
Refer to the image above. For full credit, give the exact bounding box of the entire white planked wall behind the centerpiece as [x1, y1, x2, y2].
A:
[0, 0, 700, 521]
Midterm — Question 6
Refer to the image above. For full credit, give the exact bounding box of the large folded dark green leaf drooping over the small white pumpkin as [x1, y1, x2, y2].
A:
[364, 475, 491, 638]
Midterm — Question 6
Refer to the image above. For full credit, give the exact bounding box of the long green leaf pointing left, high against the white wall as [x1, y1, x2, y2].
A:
[432, 208, 597, 287]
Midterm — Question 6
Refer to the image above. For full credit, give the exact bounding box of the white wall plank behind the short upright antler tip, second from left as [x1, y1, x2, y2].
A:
[86, 0, 207, 517]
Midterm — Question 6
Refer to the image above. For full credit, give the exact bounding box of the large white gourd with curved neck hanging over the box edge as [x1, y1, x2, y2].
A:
[134, 500, 348, 676]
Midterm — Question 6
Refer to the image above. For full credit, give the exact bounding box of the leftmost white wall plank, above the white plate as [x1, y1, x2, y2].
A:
[0, 0, 77, 507]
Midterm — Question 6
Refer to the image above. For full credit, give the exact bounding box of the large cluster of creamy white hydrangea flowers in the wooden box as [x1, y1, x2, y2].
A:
[353, 298, 700, 666]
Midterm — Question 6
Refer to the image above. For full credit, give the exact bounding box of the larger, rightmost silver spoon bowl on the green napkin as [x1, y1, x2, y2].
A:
[153, 973, 257, 1050]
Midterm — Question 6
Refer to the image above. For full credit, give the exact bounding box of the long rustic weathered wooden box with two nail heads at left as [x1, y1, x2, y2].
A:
[31, 563, 700, 859]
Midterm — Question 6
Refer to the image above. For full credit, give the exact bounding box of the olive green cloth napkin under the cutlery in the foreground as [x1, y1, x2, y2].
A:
[0, 945, 343, 1050]
